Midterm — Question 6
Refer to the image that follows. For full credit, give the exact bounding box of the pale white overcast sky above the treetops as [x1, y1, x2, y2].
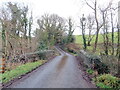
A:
[0, 0, 119, 34]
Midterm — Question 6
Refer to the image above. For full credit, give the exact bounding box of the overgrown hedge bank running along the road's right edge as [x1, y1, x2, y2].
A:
[64, 43, 120, 88]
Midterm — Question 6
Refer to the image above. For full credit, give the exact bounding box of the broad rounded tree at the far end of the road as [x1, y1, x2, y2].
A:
[36, 14, 65, 47]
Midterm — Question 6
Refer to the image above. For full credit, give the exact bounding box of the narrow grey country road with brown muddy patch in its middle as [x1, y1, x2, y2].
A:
[9, 48, 94, 88]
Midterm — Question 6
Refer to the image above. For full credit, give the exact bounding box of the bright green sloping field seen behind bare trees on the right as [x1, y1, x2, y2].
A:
[75, 32, 118, 55]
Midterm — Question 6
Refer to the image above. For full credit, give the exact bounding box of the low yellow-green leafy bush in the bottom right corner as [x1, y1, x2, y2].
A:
[94, 74, 120, 88]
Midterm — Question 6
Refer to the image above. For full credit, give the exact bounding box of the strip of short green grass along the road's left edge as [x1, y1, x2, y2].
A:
[0, 60, 46, 83]
